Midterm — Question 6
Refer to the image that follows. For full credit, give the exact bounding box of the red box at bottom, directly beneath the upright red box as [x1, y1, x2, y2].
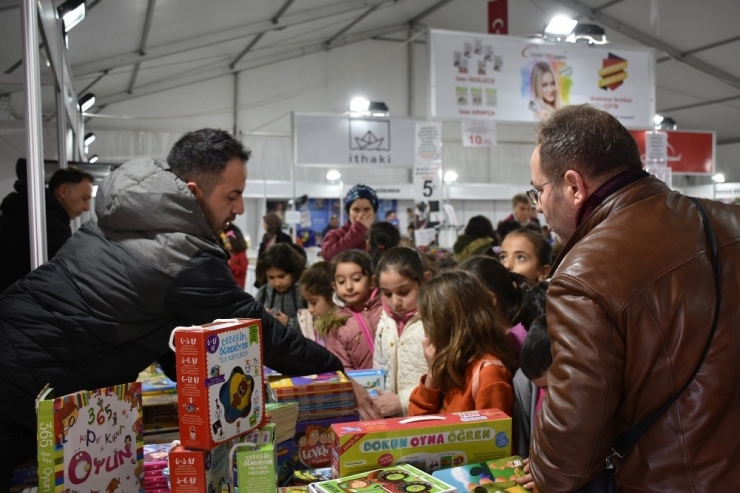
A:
[168, 440, 236, 493]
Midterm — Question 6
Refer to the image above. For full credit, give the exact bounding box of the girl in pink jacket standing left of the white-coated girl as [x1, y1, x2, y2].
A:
[325, 250, 383, 370]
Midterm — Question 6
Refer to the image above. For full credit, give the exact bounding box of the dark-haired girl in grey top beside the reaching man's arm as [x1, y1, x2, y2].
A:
[255, 243, 306, 331]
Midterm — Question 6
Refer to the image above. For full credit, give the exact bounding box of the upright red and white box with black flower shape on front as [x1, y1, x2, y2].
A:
[173, 319, 265, 450]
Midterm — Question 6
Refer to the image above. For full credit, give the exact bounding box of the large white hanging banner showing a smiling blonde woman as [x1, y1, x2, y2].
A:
[429, 30, 655, 128]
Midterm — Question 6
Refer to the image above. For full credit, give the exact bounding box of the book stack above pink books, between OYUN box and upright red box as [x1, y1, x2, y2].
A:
[137, 364, 179, 443]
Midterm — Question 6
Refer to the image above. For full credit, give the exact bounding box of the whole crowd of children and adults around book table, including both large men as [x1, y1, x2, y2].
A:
[0, 105, 740, 492]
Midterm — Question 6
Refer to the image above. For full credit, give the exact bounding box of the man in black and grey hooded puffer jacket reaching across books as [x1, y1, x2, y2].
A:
[0, 129, 373, 491]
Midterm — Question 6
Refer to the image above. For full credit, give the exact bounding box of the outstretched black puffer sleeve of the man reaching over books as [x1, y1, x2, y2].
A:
[165, 252, 344, 375]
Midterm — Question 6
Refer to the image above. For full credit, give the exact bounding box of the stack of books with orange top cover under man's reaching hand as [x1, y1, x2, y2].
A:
[267, 372, 355, 421]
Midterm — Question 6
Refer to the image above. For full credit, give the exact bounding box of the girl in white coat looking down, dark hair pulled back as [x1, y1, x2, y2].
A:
[373, 247, 433, 417]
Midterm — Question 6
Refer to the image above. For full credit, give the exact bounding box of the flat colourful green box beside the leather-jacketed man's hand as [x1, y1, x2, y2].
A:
[432, 455, 527, 493]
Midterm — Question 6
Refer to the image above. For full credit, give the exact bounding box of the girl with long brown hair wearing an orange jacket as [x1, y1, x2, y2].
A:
[409, 270, 514, 415]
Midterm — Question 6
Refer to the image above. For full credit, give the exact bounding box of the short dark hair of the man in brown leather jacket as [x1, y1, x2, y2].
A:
[537, 104, 642, 183]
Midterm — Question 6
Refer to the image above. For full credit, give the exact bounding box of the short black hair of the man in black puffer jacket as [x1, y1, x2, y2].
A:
[167, 128, 252, 182]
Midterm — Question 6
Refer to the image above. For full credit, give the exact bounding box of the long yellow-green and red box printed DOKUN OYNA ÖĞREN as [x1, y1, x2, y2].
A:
[331, 409, 511, 477]
